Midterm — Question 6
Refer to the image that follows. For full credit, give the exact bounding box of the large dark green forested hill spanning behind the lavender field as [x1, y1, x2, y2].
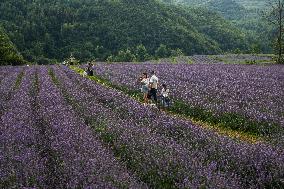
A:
[0, 0, 251, 61]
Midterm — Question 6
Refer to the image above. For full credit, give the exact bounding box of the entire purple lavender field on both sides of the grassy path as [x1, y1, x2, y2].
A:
[0, 63, 284, 188]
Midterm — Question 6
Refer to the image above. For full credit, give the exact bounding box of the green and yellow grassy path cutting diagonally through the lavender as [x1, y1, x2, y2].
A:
[70, 66, 283, 144]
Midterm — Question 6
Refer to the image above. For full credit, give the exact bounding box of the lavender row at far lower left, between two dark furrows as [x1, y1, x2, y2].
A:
[0, 69, 47, 188]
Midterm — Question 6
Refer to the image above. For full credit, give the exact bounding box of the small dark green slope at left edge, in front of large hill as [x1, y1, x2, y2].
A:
[0, 27, 24, 66]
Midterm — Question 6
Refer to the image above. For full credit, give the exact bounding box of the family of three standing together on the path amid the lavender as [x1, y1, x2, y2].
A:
[139, 71, 170, 107]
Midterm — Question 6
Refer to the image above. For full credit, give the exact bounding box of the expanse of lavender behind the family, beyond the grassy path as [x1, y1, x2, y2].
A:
[91, 63, 284, 126]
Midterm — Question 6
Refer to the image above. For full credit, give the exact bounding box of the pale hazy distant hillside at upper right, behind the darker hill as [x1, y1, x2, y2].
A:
[164, 0, 274, 53]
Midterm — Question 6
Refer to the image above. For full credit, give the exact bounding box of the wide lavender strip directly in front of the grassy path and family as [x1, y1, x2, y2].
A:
[54, 65, 283, 188]
